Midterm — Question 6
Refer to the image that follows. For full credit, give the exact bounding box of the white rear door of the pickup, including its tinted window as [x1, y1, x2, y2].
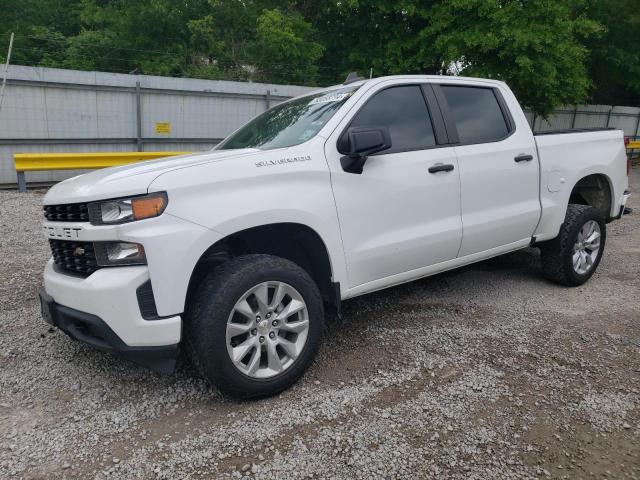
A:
[434, 84, 540, 257]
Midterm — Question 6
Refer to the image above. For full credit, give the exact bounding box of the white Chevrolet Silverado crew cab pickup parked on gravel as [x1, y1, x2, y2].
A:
[41, 76, 629, 398]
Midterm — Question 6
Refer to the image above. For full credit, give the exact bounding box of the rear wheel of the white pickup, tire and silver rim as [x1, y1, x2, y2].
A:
[540, 204, 607, 286]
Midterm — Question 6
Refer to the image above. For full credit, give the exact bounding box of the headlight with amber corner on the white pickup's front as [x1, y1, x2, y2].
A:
[89, 192, 168, 225]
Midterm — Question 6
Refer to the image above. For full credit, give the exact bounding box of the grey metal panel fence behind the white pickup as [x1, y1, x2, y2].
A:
[0, 66, 640, 185]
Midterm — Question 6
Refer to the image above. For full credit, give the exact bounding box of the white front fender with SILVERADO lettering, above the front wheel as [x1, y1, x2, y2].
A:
[149, 137, 346, 304]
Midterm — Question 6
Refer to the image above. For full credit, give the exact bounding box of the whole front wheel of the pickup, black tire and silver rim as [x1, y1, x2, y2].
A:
[185, 255, 324, 398]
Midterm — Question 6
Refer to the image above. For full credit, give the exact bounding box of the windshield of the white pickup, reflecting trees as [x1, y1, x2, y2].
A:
[216, 87, 358, 150]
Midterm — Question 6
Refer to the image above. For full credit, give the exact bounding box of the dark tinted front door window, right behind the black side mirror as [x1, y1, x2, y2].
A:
[351, 85, 436, 154]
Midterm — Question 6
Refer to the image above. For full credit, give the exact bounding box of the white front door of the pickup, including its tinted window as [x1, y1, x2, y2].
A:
[325, 83, 462, 290]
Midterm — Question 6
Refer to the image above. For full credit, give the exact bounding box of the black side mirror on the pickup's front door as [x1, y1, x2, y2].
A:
[338, 127, 391, 174]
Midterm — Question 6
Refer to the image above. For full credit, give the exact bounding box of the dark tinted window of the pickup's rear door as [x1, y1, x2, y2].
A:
[442, 85, 509, 143]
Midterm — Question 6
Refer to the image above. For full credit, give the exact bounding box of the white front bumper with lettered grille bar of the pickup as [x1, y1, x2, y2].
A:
[38, 204, 220, 370]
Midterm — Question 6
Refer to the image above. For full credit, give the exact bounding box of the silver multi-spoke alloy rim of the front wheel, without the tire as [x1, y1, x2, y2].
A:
[226, 281, 309, 378]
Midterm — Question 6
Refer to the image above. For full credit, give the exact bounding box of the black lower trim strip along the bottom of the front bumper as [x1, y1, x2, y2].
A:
[40, 289, 180, 373]
